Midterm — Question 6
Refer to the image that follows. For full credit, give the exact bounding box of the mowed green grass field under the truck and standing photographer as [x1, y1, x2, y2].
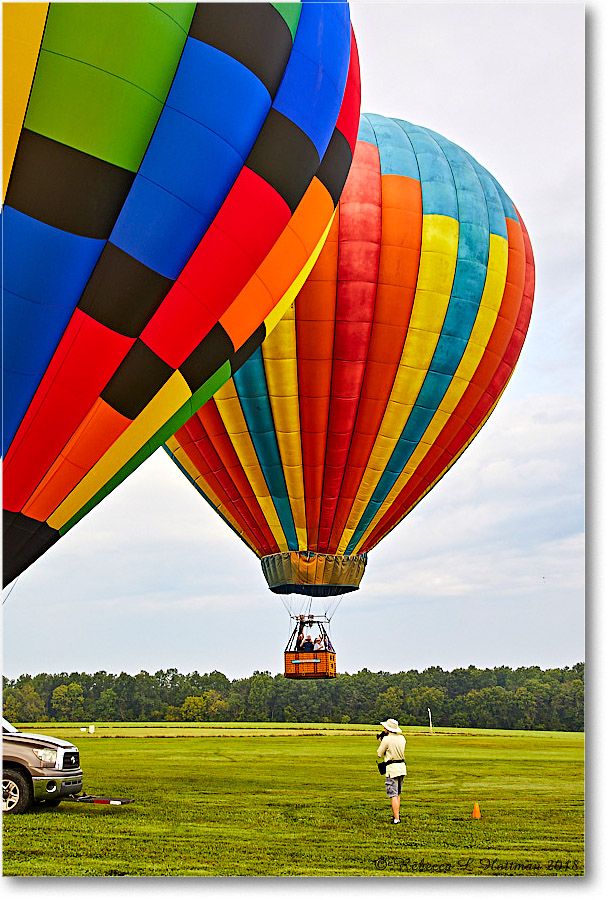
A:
[3, 723, 584, 876]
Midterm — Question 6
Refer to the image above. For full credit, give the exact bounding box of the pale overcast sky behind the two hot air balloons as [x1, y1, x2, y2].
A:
[3, 2, 588, 678]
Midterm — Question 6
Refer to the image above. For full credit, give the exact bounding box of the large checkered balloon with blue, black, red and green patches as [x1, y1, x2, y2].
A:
[2, 2, 359, 584]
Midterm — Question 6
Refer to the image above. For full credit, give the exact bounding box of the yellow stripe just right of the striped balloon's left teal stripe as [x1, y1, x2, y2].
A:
[261, 306, 308, 550]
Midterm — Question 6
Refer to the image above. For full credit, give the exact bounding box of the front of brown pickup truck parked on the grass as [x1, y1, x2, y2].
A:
[2, 719, 82, 813]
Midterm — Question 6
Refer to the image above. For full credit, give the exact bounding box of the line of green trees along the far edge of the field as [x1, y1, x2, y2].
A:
[3, 662, 585, 731]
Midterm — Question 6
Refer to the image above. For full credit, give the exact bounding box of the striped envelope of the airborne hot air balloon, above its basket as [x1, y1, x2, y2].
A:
[167, 115, 534, 676]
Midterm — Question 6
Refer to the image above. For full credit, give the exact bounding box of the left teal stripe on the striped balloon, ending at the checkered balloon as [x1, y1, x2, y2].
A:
[233, 349, 298, 550]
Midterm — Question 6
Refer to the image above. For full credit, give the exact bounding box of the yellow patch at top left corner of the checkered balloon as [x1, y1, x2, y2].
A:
[2, 3, 49, 197]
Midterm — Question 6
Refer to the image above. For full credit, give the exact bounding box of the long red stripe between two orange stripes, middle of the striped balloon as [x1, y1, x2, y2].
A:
[319, 143, 382, 546]
